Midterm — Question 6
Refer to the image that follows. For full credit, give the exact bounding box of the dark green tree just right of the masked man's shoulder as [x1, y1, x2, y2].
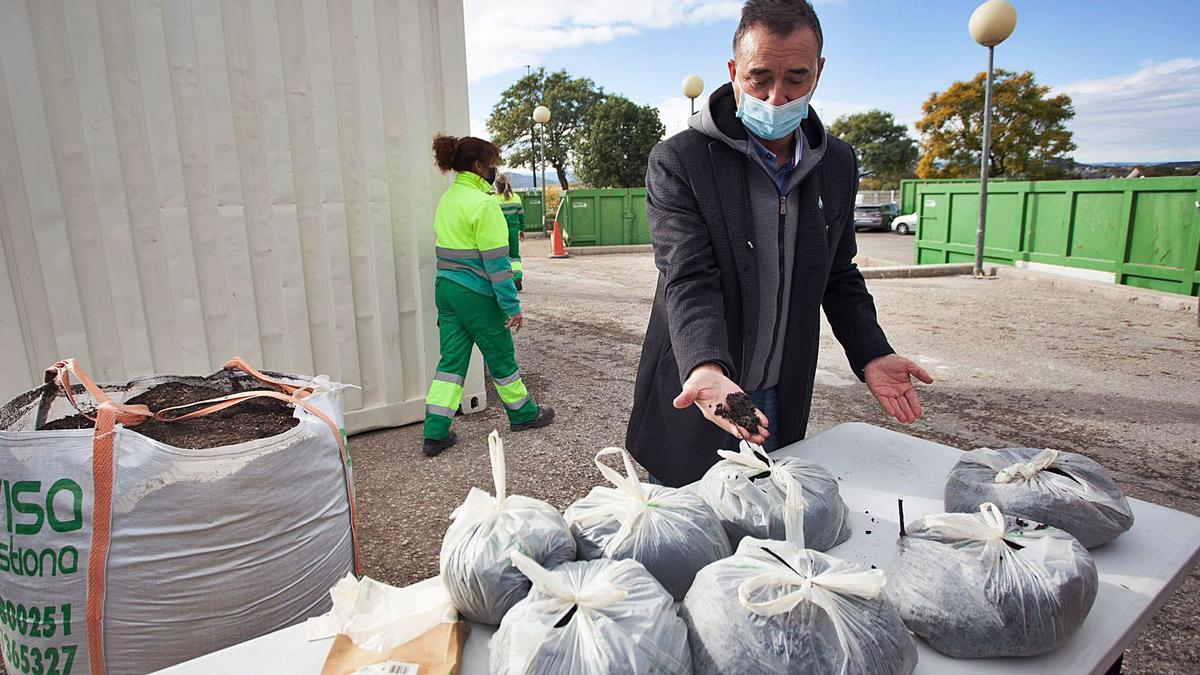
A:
[829, 110, 917, 190]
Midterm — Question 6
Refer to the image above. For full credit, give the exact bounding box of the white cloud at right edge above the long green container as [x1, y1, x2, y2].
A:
[1055, 58, 1200, 162]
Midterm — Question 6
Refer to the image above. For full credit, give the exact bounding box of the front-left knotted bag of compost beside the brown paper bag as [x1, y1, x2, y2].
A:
[488, 552, 691, 675]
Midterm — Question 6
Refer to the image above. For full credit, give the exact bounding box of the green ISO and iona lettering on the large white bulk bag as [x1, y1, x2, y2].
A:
[0, 478, 83, 577]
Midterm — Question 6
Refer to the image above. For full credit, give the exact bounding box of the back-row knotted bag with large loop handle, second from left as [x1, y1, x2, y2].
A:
[565, 448, 732, 599]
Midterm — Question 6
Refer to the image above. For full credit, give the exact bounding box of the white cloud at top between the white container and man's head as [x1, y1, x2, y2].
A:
[463, 0, 742, 80]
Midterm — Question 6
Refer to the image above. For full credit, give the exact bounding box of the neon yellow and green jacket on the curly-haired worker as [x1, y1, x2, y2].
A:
[433, 172, 521, 316]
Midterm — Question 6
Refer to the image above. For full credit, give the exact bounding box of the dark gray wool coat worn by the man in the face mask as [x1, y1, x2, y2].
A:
[625, 84, 893, 486]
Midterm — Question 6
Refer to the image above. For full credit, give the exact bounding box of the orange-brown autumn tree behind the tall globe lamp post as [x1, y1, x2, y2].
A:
[917, 70, 1075, 179]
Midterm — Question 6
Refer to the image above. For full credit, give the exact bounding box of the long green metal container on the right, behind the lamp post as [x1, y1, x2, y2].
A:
[914, 177, 1200, 295]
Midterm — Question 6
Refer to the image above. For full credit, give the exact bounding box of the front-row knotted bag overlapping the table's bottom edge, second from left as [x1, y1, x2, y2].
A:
[682, 537, 917, 675]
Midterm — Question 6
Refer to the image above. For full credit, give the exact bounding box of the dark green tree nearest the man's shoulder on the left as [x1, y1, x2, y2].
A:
[574, 96, 666, 187]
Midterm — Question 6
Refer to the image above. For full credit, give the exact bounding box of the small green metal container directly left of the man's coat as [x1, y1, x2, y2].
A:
[558, 187, 650, 246]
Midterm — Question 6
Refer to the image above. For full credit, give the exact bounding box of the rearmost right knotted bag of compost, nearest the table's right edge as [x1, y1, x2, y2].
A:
[946, 448, 1133, 549]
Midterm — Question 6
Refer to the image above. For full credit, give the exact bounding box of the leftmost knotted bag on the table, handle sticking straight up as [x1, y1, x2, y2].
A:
[440, 431, 575, 626]
